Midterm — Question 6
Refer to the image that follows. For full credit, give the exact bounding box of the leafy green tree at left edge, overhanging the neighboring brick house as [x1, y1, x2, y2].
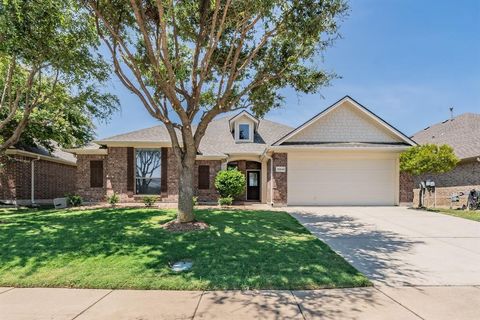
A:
[0, 0, 118, 155]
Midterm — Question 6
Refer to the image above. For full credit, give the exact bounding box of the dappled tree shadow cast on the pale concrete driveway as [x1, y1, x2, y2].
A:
[292, 211, 426, 285]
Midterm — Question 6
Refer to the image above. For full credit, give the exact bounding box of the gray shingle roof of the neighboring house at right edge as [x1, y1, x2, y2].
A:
[412, 113, 480, 159]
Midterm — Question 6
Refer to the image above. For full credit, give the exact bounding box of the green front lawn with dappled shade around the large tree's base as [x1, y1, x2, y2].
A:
[0, 209, 370, 290]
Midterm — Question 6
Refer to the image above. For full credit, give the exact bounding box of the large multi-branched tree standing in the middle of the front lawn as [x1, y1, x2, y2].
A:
[84, 0, 347, 222]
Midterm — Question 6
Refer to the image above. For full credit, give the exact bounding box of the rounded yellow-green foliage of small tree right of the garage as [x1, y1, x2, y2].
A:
[400, 144, 459, 176]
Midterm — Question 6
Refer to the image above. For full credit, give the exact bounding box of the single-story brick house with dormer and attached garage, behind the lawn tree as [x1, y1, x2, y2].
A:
[69, 96, 415, 205]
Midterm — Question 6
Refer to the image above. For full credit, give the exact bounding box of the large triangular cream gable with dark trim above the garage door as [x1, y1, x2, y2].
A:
[274, 96, 415, 145]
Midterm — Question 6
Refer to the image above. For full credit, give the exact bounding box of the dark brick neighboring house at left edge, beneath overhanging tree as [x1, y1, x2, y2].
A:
[0, 146, 77, 204]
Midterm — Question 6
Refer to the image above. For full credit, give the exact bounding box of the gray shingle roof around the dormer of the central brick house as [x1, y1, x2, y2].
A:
[96, 117, 293, 156]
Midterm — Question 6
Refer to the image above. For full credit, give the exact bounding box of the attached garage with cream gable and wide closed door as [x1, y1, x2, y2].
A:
[270, 96, 416, 206]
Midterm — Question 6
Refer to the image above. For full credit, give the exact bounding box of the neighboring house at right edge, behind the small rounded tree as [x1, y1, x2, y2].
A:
[408, 113, 480, 206]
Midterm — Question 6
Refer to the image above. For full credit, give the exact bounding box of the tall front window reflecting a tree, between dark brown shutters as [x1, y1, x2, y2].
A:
[135, 149, 161, 194]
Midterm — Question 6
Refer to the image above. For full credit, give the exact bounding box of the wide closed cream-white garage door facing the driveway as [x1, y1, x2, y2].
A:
[287, 153, 398, 205]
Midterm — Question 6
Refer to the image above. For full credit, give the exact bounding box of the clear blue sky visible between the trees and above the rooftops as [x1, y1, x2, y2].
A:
[93, 0, 480, 138]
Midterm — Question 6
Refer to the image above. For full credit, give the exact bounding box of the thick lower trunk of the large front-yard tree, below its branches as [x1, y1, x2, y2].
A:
[177, 154, 195, 223]
